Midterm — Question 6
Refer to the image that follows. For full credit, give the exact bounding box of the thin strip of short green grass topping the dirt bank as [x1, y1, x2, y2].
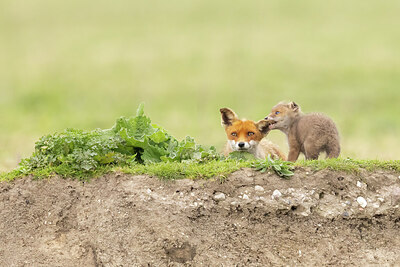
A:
[0, 159, 400, 181]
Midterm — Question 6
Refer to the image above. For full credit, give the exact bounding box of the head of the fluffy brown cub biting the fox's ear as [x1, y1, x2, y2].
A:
[265, 102, 301, 130]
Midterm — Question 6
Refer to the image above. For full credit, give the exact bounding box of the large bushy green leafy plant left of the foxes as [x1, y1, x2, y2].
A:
[18, 104, 222, 177]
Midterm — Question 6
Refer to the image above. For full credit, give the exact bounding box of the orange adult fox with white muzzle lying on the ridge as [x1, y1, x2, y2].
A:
[220, 108, 286, 160]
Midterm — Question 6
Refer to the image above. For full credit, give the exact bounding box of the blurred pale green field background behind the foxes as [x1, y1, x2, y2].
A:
[0, 0, 400, 170]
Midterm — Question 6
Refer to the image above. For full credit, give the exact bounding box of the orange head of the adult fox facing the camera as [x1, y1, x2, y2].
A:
[219, 108, 269, 151]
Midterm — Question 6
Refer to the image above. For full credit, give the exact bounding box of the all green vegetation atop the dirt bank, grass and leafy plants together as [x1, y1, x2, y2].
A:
[0, 104, 400, 181]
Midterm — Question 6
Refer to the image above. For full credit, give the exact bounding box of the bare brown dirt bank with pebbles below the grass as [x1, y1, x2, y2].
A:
[0, 169, 400, 266]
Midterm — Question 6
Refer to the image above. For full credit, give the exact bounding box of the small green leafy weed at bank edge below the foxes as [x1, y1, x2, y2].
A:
[252, 155, 294, 178]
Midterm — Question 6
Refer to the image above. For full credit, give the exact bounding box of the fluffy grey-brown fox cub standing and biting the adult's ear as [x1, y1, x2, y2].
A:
[265, 102, 340, 161]
